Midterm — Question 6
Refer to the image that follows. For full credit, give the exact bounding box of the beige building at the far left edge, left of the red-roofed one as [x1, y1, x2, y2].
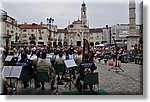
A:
[0, 10, 20, 46]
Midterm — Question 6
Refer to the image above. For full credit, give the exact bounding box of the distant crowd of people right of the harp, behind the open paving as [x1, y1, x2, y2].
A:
[96, 45, 143, 64]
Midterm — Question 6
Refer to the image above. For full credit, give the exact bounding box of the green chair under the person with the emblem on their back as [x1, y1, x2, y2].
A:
[80, 72, 99, 92]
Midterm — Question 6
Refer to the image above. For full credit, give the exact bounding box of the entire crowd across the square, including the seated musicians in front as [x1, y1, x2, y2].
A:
[1, 45, 143, 94]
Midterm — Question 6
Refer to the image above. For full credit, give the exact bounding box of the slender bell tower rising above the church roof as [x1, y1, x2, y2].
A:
[81, 1, 87, 26]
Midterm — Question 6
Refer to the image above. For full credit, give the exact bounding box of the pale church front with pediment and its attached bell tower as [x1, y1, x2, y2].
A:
[67, 2, 90, 46]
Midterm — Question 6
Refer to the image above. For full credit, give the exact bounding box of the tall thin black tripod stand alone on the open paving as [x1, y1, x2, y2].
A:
[108, 37, 124, 72]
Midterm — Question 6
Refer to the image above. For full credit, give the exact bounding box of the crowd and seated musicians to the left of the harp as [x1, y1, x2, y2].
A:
[1, 46, 93, 94]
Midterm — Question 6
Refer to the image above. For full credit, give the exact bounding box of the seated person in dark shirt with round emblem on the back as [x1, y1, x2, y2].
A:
[76, 54, 97, 91]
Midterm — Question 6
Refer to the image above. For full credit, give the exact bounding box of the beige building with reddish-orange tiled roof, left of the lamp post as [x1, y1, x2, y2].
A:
[19, 23, 49, 46]
